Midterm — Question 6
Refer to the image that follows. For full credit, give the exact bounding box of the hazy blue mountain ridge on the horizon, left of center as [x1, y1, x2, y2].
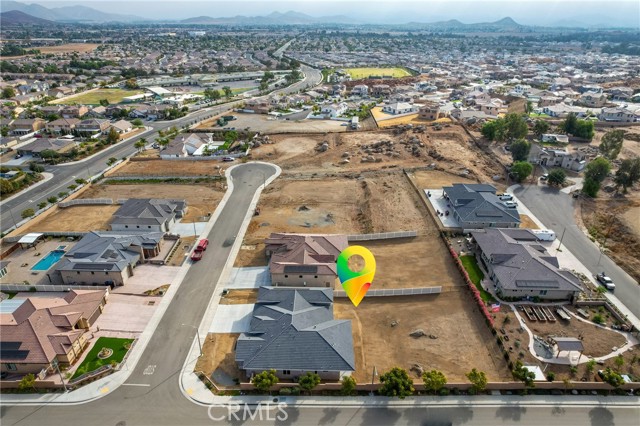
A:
[179, 11, 357, 25]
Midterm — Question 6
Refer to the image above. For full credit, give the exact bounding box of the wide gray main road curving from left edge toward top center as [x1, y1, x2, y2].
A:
[0, 65, 322, 232]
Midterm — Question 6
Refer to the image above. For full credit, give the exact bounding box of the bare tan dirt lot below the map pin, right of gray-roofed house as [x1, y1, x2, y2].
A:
[334, 291, 511, 382]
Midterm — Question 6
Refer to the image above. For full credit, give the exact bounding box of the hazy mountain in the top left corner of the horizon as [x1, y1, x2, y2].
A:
[0, 1, 145, 23]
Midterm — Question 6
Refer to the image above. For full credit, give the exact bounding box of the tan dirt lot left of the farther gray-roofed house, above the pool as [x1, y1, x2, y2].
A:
[24, 205, 120, 233]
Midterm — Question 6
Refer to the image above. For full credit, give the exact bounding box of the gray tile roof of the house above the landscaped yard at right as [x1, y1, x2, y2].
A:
[471, 228, 582, 291]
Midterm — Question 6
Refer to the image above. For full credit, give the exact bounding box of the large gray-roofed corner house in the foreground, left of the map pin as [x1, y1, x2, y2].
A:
[236, 287, 356, 381]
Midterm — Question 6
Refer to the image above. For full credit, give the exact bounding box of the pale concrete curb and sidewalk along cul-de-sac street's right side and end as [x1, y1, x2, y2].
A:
[179, 161, 282, 405]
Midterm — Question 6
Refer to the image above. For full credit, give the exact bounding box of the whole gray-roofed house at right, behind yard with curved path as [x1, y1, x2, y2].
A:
[471, 229, 583, 300]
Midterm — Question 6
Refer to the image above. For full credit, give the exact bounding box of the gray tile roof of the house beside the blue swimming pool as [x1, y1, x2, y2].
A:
[56, 231, 164, 271]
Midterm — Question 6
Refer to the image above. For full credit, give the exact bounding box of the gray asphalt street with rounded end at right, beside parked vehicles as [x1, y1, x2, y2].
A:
[514, 185, 640, 317]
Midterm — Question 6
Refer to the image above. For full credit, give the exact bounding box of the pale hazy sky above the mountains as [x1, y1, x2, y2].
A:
[7, 0, 640, 29]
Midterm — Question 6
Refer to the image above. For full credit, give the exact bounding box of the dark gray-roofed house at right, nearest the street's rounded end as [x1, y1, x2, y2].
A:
[442, 183, 520, 230]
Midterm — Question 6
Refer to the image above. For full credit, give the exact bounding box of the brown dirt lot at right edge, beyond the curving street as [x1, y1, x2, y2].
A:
[581, 196, 640, 281]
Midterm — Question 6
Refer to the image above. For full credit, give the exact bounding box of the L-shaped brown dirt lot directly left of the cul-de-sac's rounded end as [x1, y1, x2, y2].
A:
[81, 182, 224, 222]
